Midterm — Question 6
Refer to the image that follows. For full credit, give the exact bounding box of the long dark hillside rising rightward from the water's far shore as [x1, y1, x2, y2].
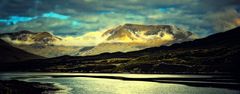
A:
[1, 27, 240, 74]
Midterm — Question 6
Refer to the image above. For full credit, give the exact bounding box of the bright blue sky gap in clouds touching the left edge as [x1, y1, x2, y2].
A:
[0, 16, 38, 25]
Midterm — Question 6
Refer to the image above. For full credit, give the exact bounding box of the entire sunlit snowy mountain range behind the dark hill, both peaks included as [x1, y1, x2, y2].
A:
[0, 24, 193, 58]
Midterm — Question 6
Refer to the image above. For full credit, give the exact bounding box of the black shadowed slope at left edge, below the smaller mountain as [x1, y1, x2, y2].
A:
[0, 39, 43, 63]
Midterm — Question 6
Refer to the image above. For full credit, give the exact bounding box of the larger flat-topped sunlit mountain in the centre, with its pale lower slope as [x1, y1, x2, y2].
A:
[79, 24, 194, 56]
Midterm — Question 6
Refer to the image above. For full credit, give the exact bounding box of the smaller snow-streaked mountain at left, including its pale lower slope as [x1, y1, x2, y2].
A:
[0, 30, 80, 58]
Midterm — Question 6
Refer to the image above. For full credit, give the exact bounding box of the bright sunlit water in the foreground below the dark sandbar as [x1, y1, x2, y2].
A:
[27, 77, 240, 94]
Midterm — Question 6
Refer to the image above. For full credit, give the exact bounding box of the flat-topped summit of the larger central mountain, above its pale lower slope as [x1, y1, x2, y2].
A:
[102, 24, 192, 42]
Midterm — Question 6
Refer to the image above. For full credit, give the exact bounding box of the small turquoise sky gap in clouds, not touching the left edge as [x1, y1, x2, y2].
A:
[42, 12, 70, 20]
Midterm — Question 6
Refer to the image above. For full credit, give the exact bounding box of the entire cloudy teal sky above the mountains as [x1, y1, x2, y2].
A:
[0, 0, 240, 37]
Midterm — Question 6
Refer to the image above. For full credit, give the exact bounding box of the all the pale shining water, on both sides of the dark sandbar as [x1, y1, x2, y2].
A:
[1, 73, 240, 94]
